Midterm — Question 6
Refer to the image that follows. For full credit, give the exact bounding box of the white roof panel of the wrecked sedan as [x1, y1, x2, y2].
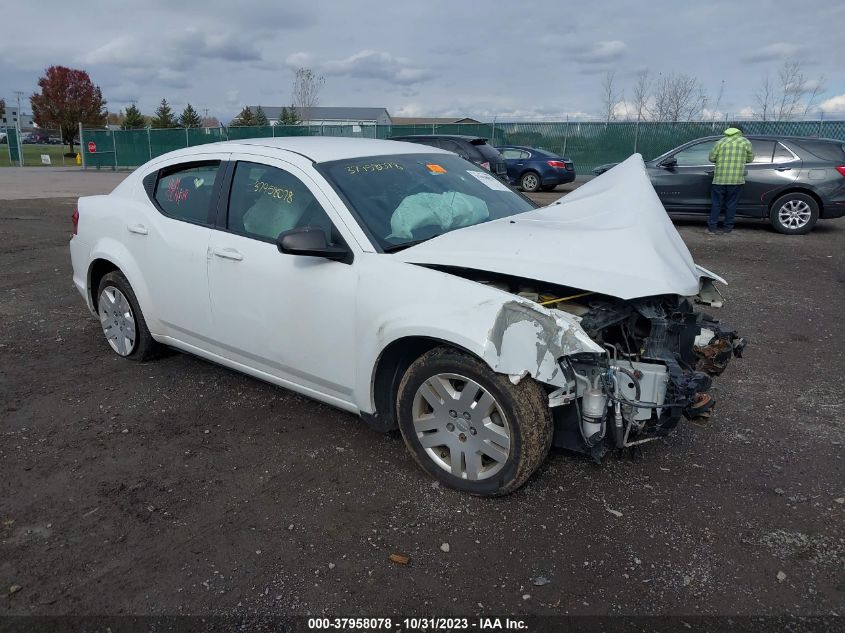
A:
[157, 136, 450, 163]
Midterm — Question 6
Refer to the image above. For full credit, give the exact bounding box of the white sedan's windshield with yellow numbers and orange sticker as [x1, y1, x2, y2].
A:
[317, 154, 536, 252]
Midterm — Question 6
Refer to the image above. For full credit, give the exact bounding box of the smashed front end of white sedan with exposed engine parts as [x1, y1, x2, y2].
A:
[549, 292, 745, 460]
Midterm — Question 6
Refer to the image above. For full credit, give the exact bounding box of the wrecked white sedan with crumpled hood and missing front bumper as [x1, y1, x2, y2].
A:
[70, 138, 743, 495]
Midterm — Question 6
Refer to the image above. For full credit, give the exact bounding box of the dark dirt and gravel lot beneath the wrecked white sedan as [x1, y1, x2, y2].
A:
[0, 189, 845, 616]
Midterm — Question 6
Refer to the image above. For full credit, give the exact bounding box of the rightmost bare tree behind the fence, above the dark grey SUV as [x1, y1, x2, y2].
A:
[754, 60, 824, 121]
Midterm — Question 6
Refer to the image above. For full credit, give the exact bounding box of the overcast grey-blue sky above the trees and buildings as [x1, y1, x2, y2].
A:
[0, 0, 845, 123]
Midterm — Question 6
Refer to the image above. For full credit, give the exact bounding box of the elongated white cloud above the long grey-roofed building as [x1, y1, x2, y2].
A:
[285, 50, 433, 86]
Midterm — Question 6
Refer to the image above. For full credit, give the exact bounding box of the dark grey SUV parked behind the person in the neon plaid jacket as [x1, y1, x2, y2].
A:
[593, 136, 845, 235]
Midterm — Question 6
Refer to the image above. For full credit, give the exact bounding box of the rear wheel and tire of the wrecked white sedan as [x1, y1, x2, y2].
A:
[97, 271, 159, 362]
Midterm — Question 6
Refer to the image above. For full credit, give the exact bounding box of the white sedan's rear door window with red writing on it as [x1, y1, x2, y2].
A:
[154, 161, 220, 224]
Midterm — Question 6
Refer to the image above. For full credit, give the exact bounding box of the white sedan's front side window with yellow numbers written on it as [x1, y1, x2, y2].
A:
[226, 162, 332, 242]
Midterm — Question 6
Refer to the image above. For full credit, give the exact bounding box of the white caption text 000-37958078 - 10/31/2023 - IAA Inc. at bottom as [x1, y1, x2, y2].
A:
[308, 617, 528, 631]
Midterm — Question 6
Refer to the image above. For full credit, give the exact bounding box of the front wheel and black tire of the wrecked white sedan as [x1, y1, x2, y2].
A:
[396, 347, 552, 496]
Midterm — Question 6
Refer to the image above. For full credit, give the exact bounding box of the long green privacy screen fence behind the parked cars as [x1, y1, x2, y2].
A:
[81, 120, 845, 174]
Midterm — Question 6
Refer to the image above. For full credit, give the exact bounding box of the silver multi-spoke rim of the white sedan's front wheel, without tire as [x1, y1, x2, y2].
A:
[412, 374, 511, 481]
